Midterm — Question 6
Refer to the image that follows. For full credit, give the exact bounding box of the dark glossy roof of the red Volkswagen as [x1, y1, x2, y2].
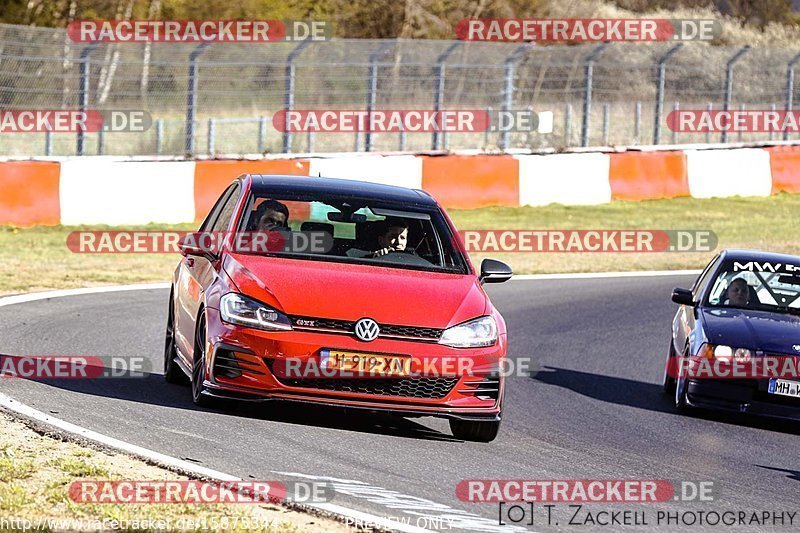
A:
[249, 174, 436, 207]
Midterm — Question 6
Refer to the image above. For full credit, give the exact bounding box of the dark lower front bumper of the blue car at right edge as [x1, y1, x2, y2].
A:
[686, 379, 800, 421]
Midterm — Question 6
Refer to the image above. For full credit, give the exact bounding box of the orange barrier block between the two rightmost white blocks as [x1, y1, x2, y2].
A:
[609, 152, 689, 200]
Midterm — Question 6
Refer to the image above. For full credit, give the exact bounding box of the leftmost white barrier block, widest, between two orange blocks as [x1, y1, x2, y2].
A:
[61, 157, 194, 225]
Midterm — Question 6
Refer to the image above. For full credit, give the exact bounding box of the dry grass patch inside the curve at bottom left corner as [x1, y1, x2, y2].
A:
[0, 413, 348, 533]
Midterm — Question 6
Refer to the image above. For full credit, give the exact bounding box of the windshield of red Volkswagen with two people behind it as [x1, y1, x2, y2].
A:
[237, 193, 467, 274]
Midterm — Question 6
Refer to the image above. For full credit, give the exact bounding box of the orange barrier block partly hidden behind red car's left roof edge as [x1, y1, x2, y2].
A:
[194, 159, 308, 221]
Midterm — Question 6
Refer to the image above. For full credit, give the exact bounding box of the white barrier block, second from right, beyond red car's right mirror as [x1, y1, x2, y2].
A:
[514, 153, 611, 205]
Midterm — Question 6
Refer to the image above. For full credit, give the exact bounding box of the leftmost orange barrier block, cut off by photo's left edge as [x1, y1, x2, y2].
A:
[0, 161, 61, 227]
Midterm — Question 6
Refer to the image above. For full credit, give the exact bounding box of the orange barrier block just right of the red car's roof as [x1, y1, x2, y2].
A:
[422, 155, 519, 209]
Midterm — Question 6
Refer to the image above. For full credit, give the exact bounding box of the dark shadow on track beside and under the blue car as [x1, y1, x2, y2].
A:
[531, 366, 800, 435]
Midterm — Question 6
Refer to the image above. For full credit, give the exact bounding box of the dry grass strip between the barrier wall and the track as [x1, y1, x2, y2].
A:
[0, 194, 800, 294]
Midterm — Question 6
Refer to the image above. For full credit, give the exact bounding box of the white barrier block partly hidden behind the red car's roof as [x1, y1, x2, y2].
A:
[308, 155, 422, 189]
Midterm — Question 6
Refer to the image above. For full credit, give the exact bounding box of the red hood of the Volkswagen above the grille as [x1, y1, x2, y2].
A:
[224, 254, 489, 328]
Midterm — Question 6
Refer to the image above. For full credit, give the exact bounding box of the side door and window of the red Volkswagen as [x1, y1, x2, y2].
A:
[175, 182, 241, 365]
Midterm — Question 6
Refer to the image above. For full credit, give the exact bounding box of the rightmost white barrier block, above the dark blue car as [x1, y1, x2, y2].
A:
[686, 148, 772, 198]
